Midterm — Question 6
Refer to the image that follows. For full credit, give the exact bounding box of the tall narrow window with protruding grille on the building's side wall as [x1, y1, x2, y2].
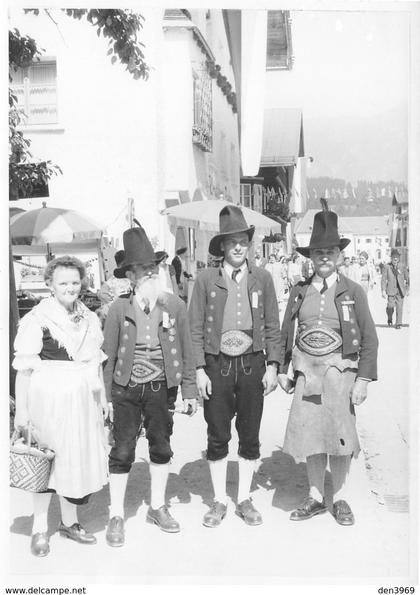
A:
[192, 69, 213, 152]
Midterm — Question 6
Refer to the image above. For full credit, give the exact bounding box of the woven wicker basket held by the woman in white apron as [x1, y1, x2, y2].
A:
[9, 426, 54, 492]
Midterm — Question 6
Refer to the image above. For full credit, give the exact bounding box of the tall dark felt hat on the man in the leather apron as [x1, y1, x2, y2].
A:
[295, 198, 351, 258]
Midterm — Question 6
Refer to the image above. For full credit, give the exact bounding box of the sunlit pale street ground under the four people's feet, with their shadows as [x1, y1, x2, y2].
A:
[9, 280, 417, 586]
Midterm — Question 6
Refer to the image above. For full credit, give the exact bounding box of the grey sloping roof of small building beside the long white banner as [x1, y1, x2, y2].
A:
[260, 108, 305, 167]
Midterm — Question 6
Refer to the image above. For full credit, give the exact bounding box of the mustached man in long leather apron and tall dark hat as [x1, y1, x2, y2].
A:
[279, 201, 378, 525]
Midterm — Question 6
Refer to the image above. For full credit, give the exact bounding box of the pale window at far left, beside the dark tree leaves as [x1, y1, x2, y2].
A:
[12, 61, 58, 125]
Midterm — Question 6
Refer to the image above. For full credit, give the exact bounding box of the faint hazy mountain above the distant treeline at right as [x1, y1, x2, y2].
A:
[304, 106, 408, 184]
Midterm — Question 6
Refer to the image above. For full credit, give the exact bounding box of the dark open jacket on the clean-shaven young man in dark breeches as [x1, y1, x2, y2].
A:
[188, 265, 280, 367]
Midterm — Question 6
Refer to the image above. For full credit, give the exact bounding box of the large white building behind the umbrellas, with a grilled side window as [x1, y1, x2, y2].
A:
[10, 8, 240, 274]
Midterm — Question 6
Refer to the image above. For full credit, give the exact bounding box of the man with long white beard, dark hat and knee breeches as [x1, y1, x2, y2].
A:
[103, 226, 197, 547]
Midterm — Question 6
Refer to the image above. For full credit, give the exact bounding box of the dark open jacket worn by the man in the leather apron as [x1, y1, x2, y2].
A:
[279, 274, 378, 380]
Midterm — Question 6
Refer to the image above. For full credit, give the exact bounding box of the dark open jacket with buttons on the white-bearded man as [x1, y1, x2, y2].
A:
[102, 293, 197, 401]
